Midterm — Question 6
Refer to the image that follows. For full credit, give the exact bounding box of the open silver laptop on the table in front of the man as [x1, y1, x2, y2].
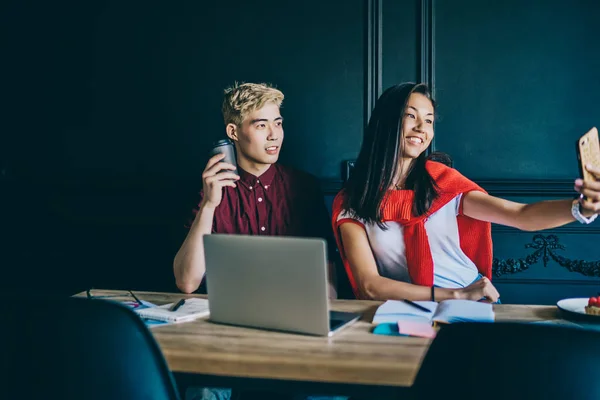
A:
[203, 234, 360, 336]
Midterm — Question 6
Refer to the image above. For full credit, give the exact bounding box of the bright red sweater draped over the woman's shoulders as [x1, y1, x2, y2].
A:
[332, 161, 492, 298]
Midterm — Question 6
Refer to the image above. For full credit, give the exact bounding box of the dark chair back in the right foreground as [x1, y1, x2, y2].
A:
[412, 323, 600, 400]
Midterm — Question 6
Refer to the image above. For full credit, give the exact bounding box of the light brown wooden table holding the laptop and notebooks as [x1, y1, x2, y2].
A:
[78, 290, 558, 397]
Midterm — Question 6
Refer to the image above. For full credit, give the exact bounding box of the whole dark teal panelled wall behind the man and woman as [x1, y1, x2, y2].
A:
[0, 0, 600, 303]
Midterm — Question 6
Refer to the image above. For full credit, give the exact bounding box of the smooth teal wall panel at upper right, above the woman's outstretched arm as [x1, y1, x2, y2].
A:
[434, 0, 600, 180]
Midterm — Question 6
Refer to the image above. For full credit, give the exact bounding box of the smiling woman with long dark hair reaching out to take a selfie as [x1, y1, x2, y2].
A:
[332, 83, 600, 302]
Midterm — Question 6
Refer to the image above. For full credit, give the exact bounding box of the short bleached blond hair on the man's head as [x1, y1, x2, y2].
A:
[222, 82, 284, 126]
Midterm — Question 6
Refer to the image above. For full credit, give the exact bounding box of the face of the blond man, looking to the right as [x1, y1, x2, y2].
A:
[228, 103, 283, 164]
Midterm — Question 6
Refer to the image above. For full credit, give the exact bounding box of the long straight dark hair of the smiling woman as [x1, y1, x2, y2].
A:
[344, 83, 443, 229]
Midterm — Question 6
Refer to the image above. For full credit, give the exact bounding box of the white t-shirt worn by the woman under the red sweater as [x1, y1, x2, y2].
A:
[337, 194, 479, 288]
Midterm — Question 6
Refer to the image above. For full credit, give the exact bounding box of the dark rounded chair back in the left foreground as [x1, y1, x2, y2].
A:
[0, 296, 179, 400]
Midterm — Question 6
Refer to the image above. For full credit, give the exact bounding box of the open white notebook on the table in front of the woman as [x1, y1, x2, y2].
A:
[373, 300, 495, 325]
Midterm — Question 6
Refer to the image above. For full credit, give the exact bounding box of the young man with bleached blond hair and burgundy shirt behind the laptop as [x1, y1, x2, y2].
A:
[173, 83, 336, 297]
